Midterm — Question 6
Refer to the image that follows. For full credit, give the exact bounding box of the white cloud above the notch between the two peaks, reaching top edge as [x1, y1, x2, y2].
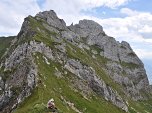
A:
[43, 0, 132, 25]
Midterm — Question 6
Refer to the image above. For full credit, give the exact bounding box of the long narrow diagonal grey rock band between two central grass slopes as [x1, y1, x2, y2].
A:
[65, 59, 128, 112]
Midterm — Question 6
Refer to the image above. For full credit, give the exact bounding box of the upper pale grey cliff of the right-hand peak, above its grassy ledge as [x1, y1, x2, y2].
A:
[69, 20, 143, 65]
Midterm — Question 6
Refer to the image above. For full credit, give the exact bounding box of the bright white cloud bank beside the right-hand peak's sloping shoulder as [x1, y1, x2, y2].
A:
[95, 9, 152, 43]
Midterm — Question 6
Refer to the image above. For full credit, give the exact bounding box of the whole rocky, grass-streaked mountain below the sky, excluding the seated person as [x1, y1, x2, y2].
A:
[0, 10, 152, 113]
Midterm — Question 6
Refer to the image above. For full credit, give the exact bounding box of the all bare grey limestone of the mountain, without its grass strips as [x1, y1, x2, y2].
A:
[0, 10, 149, 112]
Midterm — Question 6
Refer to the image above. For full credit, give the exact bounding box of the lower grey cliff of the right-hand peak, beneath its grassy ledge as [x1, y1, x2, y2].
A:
[105, 61, 149, 101]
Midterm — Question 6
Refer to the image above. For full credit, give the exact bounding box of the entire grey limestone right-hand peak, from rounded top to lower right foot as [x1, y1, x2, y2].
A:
[69, 20, 149, 100]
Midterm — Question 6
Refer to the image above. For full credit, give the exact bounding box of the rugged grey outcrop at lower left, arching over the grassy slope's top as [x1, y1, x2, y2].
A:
[0, 41, 53, 113]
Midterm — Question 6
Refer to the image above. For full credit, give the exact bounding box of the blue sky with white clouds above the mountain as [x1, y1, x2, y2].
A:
[0, 0, 152, 84]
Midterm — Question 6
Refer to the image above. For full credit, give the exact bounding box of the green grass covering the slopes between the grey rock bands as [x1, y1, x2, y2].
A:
[15, 18, 152, 113]
